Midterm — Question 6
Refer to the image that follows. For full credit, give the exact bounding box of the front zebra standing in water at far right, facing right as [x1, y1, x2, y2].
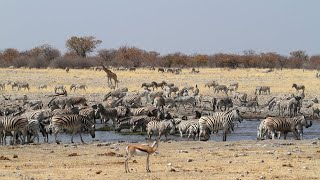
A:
[265, 116, 312, 139]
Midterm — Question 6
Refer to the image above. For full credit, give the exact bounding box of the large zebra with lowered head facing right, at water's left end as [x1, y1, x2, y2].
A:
[51, 115, 95, 144]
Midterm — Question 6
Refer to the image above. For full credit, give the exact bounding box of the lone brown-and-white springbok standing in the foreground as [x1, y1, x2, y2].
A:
[124, 139, 159, 173]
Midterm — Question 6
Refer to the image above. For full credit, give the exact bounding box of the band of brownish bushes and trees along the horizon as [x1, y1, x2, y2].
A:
[0, 36, 320, 69]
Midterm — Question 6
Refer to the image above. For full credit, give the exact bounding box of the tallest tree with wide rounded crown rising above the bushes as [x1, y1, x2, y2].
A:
[66, 36, 102, 58]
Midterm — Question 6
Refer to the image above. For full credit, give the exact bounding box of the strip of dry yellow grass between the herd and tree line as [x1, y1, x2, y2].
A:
[0, 68, 320, 97]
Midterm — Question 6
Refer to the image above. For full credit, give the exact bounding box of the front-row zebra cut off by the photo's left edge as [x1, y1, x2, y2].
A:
[0, 116, 28, 144]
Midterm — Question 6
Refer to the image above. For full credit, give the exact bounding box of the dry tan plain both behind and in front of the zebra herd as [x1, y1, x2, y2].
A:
[0, 68, 320, 179]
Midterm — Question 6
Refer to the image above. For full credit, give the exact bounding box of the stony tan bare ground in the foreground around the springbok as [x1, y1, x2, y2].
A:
[0, 140, 320, 180]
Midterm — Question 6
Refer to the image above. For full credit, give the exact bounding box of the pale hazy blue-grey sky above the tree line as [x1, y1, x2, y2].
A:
[0, 0, 320, 55]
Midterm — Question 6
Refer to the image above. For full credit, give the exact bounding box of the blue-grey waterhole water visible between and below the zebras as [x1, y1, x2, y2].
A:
[53, 120, 320, 143]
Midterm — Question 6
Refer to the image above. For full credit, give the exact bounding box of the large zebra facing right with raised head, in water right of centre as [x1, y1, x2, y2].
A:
[199, 109, 242, 141]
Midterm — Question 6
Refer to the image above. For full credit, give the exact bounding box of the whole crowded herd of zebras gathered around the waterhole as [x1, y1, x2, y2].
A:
[0, 81, 320, 144]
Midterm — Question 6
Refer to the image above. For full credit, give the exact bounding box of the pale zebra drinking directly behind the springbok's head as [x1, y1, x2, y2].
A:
[146, 119, 175, 140]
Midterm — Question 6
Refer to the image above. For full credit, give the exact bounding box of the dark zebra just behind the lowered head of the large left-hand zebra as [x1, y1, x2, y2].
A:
[94, 104, 118, 126]
